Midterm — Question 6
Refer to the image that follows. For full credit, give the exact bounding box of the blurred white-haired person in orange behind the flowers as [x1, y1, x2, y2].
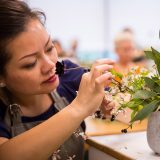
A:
[114, 31, 139, 123]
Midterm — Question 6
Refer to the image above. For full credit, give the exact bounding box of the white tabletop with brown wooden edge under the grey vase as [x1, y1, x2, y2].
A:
[87, 131, 160, 160]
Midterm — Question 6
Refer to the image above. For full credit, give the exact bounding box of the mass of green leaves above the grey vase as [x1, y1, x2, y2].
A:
[122, 48, 160, 126]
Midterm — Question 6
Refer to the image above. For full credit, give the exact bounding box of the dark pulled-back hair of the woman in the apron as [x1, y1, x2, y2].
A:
[0, 0, 46, 75]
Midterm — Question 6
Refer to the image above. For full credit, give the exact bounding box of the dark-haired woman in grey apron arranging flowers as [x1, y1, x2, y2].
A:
[0, 0, 113, 160]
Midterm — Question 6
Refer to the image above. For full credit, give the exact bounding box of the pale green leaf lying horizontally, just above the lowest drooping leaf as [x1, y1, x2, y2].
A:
[133, 90, 157, 99]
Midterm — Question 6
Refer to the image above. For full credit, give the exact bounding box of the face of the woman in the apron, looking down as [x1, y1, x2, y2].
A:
[3, 20, 59, 96]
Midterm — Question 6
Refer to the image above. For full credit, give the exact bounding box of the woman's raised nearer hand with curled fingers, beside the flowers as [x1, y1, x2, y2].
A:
[72, 59, 114, 116]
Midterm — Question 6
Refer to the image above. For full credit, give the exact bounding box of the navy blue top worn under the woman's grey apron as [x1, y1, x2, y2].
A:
[0, 60, 85, 138]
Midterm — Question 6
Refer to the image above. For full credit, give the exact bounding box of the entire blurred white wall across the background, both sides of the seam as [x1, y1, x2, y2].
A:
[28, 0, 160, 51]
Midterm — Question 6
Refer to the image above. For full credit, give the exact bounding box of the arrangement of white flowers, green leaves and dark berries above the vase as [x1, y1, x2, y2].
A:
[109, 48, 160, 133]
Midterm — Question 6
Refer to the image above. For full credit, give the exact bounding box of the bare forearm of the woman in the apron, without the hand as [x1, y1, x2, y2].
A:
[0, 105, 87, 160]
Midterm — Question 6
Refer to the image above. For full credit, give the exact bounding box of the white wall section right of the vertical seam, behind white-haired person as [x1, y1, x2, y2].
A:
[109, 0, 160, 50]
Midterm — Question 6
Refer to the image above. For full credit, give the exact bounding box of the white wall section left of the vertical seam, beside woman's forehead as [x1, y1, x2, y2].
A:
[28, 0, 104, 50]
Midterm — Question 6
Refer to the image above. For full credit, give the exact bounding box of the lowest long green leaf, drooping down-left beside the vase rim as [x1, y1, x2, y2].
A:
[130, 100, 160, 123]
